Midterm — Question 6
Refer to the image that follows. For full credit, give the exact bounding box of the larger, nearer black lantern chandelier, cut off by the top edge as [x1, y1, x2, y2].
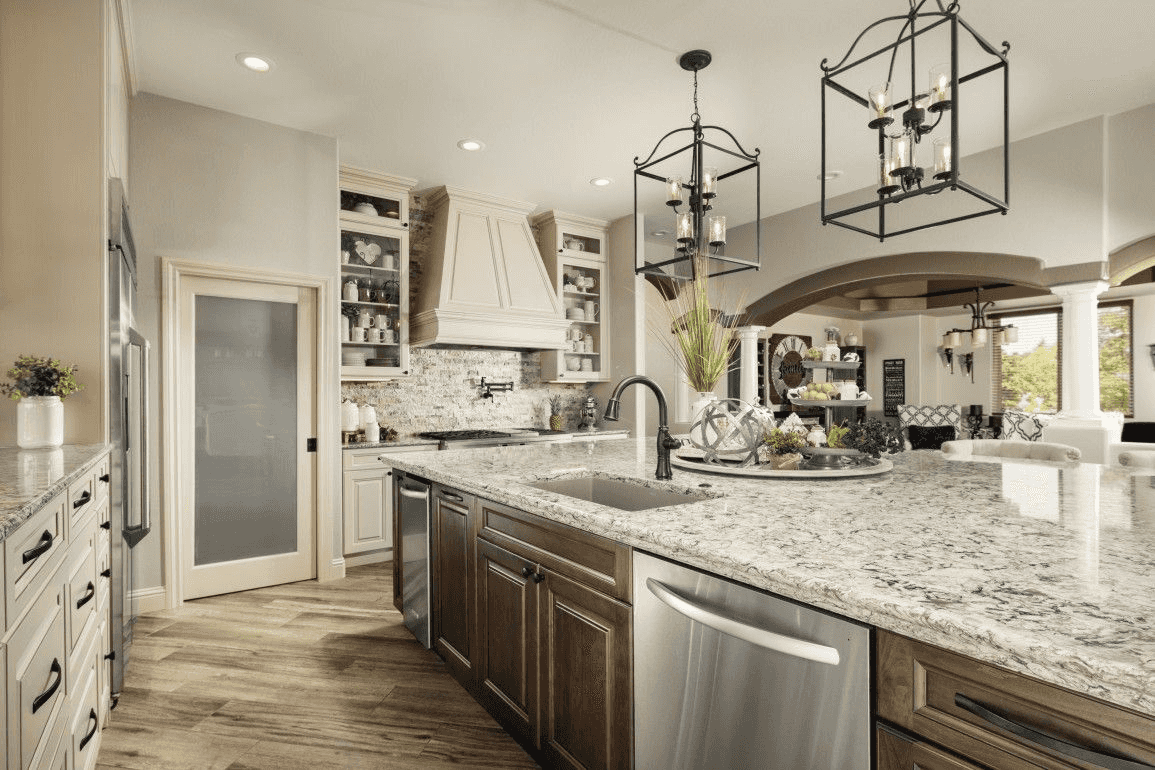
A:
[819, 0, 1011, 240]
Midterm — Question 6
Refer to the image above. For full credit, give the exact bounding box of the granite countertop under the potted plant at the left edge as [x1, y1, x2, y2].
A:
[0, 443, 109, 540]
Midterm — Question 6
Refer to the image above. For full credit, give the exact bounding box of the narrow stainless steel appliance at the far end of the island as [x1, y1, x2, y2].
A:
[394, 471, 433, 648]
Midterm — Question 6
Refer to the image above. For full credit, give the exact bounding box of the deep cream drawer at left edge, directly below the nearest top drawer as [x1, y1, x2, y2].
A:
[6, 584, 67, 770]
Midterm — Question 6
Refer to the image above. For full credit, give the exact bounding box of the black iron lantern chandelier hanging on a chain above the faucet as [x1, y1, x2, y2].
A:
[634, 51, 762, 281]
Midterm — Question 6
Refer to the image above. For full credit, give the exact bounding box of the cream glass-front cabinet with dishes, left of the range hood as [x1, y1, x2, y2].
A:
[337, 166, 417, 382]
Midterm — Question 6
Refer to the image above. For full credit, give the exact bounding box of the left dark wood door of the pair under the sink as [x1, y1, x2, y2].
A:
[474, 539, 538, 746]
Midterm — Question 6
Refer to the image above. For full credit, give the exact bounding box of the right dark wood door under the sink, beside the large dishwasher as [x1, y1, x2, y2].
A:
[537, 570, 633, 770]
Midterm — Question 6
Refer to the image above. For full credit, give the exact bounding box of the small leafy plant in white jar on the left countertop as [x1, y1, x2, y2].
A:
[0, 354, 83, 449]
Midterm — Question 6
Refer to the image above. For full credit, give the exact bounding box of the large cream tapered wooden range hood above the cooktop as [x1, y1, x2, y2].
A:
[409, 187, 569, 350]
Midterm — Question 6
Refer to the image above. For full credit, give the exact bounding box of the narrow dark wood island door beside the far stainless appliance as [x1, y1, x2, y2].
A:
[430, 484, 476, 689]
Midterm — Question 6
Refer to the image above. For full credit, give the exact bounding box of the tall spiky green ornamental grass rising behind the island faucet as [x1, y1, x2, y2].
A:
[646, 254, 745, 393]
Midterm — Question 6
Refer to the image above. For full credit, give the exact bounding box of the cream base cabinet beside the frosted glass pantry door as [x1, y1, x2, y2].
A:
[342, 444, 433, 556]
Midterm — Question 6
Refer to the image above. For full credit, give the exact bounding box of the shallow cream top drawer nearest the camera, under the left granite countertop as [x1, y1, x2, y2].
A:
[3, 494, 68, 627]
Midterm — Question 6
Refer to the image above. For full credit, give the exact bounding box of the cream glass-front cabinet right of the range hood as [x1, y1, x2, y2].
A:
[530, 211, 610, 382]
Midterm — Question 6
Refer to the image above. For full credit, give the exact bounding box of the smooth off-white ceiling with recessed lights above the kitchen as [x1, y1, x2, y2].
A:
[132, 0, 1155, 225]
